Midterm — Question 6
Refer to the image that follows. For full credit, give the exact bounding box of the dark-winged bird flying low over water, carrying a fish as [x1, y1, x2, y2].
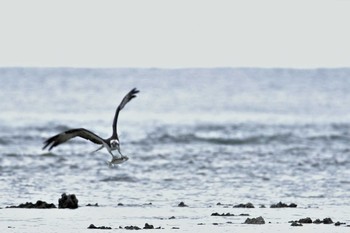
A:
[42, 88, 140, 165]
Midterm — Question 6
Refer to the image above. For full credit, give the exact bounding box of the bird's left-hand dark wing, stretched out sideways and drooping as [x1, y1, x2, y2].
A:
[43, 128, 104, 150]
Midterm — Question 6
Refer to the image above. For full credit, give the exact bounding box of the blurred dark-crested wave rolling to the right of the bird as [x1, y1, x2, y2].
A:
[134, 124, 350, 146]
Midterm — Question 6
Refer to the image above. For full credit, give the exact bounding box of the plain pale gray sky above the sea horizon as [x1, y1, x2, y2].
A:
[0, 0, 350, 68]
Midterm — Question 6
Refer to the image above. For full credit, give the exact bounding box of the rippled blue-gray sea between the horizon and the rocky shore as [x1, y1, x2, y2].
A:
[0, 68, 350, 230]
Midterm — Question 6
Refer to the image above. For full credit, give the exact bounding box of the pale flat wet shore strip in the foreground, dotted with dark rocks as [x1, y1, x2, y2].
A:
[0, 202, 350, 233]
